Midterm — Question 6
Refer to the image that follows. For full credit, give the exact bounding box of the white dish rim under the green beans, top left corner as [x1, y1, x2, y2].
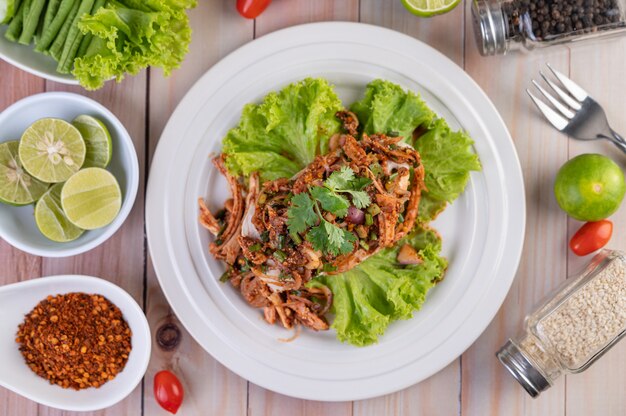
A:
[0, 25, 78, 85]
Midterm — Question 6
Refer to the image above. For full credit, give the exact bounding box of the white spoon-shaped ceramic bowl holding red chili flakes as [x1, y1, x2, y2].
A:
[0, 276, 152, 412]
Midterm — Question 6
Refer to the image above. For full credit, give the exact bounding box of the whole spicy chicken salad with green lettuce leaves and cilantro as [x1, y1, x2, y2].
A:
[199, 78, 480, 346]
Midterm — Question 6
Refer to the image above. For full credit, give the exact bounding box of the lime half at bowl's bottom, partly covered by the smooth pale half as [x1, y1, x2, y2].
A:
[35, 183, 84, 243]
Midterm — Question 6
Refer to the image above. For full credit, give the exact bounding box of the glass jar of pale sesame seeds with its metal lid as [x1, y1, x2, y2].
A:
[496, 250, 626, 397]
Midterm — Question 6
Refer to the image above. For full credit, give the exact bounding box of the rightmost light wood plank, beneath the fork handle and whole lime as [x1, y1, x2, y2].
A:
[565, 39, 626, 416]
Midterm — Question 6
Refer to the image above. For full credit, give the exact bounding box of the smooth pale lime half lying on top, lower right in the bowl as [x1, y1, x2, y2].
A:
[61, 168, 122, 230]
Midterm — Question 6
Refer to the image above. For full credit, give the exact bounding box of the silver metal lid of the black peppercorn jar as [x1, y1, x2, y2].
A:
[472, 0, 507, 56]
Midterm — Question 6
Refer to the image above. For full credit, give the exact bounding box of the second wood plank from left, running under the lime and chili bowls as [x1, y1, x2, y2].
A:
[39, 72, 147, 416]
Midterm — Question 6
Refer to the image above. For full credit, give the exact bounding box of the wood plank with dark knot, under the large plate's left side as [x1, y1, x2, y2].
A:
[144, 0, 253, 416]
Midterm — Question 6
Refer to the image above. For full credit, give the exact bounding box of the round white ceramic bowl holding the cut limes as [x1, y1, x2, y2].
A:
[0, 92, 139, 257]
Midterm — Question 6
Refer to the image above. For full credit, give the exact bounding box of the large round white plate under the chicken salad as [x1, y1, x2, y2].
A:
[146, 23, 525, 401]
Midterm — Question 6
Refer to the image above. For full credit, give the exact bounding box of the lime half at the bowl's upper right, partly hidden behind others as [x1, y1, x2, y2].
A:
[72, 116, 113, 168]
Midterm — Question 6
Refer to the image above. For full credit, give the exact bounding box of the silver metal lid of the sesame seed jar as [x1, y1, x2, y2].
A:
[496, 340, 550, 398]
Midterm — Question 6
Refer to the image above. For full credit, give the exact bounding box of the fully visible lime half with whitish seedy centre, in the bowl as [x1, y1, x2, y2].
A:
[19, 118, 86, 183]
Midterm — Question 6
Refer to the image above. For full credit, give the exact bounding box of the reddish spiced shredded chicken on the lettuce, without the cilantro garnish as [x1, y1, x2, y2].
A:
[199, 111, 424, 336]
